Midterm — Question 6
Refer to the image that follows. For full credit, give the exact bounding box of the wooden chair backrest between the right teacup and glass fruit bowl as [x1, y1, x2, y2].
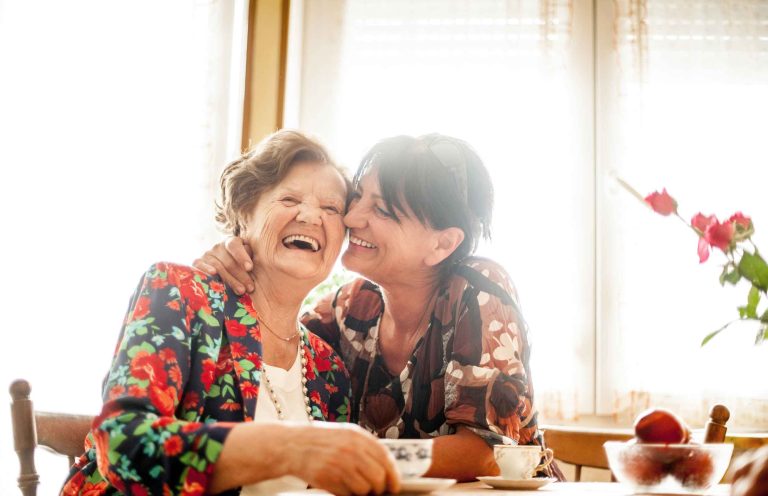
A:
[541, 425, 632, 482]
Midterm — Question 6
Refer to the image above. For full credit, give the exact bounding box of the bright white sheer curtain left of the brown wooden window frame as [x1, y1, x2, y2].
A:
[0, 0, 247, 494]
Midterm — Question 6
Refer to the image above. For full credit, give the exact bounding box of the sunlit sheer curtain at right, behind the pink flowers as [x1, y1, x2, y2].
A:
[598, 0, 768, 429]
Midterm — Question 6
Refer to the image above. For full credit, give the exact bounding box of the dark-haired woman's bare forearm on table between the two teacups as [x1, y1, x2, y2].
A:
[425, 426, 499, 482]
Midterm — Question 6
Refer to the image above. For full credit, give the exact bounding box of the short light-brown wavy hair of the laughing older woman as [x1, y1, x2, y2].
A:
[216, 129, 350, 236]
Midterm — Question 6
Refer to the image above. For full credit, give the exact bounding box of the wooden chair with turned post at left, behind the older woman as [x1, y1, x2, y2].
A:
[10, 379, 93, 496]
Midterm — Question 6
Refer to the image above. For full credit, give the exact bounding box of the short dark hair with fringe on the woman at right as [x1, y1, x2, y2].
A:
[352, 134, 493, 268]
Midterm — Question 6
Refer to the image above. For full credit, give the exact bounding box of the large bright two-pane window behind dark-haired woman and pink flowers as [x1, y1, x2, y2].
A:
[288, 0, 768, 428]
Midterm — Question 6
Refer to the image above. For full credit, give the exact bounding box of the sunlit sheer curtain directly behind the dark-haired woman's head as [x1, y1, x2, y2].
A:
[292, 0, 594, 417]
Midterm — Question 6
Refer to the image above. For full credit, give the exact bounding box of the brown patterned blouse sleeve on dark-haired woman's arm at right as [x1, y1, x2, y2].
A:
[445, 260, 541, 444]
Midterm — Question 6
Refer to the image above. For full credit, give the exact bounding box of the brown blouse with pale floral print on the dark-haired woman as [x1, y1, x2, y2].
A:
[302, 257, 559, 475]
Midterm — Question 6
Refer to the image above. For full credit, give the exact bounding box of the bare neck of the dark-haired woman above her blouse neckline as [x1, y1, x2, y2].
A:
[381, 277, 438, 337]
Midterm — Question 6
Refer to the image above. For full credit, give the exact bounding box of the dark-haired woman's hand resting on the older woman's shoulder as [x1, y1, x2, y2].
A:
[192, 236, 254, 294]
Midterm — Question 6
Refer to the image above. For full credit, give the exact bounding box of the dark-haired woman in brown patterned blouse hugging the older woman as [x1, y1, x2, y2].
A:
[195, 135, 562, 480]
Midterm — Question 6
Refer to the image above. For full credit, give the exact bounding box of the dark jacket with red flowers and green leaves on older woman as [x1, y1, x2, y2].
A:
[61, 263, 349, 496]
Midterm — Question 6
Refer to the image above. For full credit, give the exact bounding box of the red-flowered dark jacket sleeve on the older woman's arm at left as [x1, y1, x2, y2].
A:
[70, 263, 233, 494]
